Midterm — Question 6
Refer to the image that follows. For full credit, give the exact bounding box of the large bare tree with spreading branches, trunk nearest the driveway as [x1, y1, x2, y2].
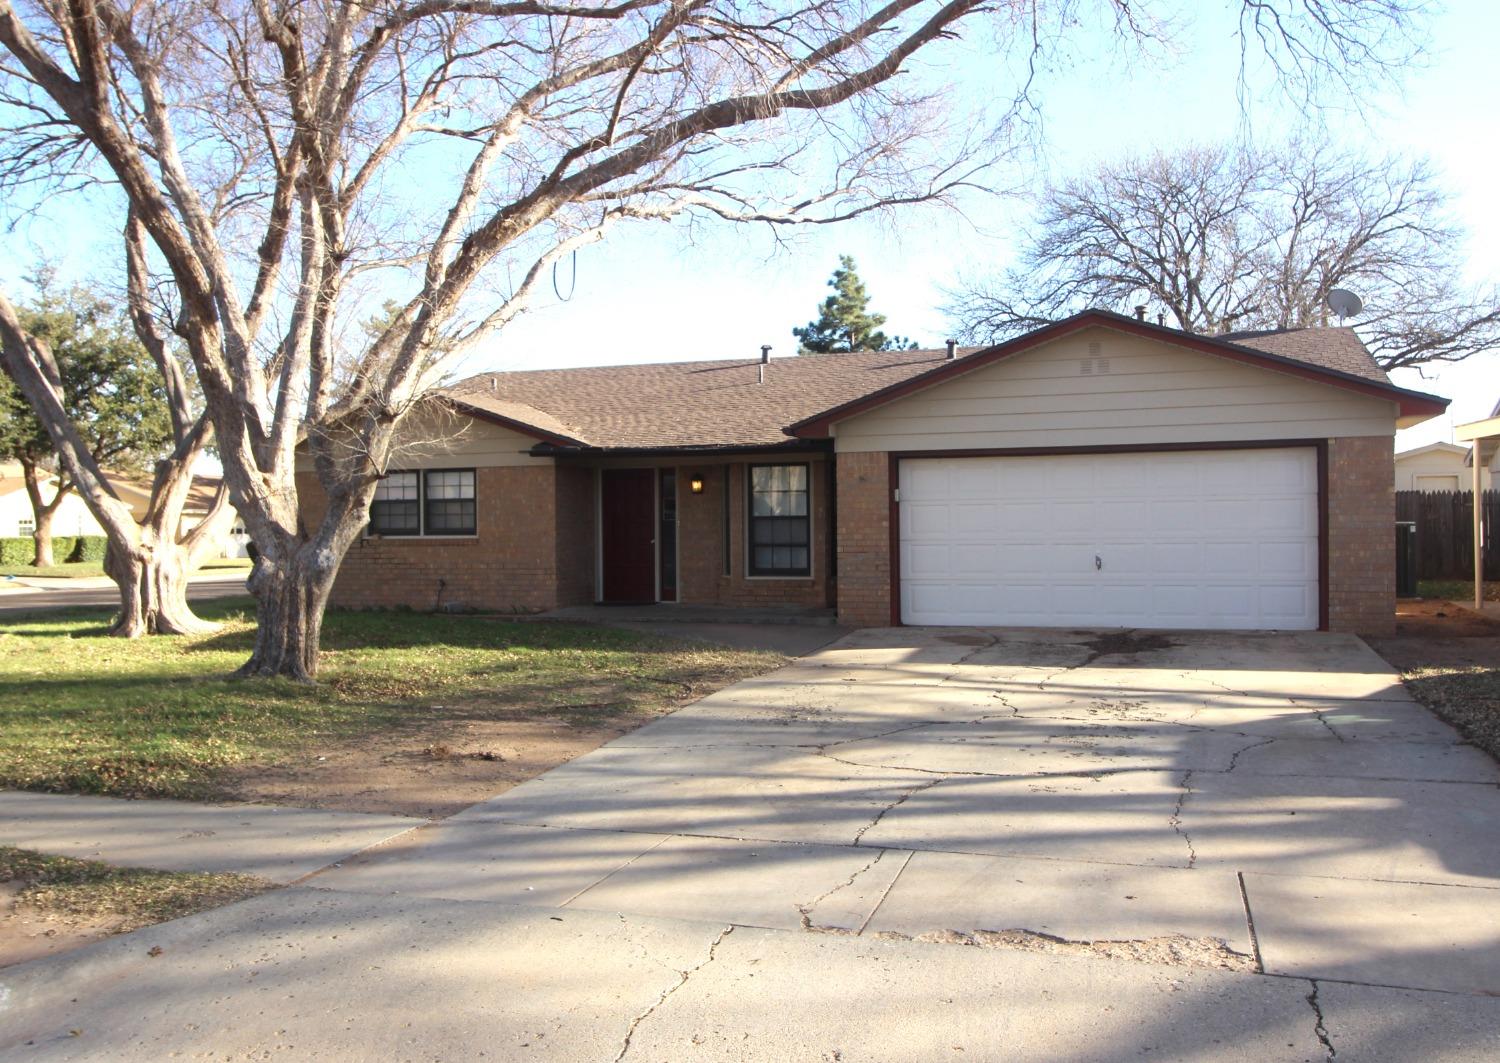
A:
[0, 0, 1428, 679]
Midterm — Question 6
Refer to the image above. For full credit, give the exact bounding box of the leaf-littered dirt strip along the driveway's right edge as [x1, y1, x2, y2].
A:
[1365, 600, 1500, 760]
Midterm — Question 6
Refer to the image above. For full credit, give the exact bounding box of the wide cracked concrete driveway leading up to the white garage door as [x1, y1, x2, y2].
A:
[0, 628, 1500, 1060]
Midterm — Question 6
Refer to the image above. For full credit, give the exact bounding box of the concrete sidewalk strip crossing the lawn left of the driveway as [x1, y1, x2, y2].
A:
[0, 790, 426, 883]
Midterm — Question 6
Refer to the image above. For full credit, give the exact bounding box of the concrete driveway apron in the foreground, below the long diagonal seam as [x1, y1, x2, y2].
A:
[0, 888, 1500, 1063]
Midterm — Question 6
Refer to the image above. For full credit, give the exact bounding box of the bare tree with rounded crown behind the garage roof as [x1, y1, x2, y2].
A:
[948, 142, 1500, 369]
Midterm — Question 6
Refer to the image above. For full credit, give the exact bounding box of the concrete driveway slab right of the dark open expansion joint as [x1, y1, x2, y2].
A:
[1245, 874, 1500, 997]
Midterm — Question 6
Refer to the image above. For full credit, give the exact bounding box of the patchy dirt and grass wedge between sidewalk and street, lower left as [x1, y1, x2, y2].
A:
[0, 846, 275, 967]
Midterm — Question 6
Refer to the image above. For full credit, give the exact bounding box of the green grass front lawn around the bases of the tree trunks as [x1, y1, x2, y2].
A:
[0, 601, 783, 798]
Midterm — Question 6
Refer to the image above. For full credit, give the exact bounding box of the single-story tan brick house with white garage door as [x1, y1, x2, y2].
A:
[300, 310, 1448, 633]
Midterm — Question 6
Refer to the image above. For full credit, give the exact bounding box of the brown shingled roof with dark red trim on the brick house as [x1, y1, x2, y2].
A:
[446, 310, 1448, 450]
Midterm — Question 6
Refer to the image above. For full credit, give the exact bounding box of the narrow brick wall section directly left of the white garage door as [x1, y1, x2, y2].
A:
[837, 451, 891, 627]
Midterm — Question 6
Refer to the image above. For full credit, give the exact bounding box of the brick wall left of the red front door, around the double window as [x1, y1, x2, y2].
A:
[297, 465, 594, 612]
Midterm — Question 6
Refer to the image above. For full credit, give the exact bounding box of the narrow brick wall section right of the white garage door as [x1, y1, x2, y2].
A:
[1328, 436, 1397, 634]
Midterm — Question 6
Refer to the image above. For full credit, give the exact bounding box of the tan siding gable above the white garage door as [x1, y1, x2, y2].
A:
[836, 328, 1397, 451]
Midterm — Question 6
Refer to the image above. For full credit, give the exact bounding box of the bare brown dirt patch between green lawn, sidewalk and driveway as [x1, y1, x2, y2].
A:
[224, 714, 639, 819]
